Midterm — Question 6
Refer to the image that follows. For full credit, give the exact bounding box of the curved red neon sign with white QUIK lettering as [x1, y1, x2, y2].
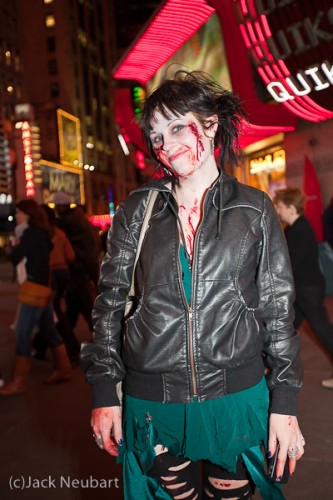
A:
[234, 0, 333, 122]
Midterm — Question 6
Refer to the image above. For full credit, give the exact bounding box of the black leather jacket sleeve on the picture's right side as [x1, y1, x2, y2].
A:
[257, 194, 303, 415]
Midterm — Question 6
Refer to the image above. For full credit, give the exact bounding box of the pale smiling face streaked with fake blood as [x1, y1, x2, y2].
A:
[150, 112, 217, 177]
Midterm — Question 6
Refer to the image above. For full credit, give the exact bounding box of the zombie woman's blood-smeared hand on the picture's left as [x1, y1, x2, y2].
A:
[90, 406, 123, 457]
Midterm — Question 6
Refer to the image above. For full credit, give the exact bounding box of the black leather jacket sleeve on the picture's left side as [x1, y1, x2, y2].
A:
[80, 201, 140, 408]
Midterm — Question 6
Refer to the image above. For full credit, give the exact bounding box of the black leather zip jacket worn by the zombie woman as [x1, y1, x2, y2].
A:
[81, 173, 302, 415]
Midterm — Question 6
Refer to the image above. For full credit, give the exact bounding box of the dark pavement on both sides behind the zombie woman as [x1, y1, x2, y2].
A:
[0, 264, 333, 500]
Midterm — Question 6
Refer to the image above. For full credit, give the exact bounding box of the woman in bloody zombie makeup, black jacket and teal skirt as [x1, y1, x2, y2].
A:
[81, 72, 305, 499]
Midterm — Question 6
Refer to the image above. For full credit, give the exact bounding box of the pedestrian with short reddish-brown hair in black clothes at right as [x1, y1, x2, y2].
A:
[274, 187, 333, 389]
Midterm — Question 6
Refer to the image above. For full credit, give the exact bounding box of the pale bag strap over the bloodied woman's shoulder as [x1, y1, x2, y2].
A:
[116, 190, 158, 404]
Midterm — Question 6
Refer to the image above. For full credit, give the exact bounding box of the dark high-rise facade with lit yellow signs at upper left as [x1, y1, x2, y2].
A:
[0, 0, 156, 230]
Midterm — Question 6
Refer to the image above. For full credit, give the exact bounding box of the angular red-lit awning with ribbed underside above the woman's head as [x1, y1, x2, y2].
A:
[113, 0, 297, 153]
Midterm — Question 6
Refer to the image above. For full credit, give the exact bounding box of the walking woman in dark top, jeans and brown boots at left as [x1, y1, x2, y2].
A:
[0, 198, 71, 396]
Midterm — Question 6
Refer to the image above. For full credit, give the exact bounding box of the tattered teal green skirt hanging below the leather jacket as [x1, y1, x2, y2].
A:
[118, 378, 284, 500]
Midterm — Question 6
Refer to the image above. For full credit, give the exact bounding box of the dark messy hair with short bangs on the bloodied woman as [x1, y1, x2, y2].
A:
[140, 70, 246, 172]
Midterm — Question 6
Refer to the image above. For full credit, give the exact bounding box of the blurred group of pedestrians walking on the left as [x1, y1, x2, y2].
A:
[0, 193, 105, 396]
